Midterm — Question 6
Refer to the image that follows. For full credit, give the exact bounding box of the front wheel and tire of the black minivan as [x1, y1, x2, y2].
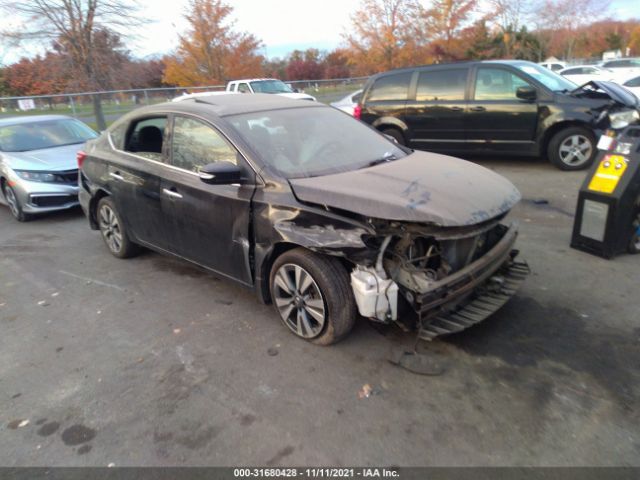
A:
[547, 127, 597, 171]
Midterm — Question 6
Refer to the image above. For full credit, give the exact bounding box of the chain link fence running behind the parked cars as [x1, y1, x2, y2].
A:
[0, 77, 367, 129]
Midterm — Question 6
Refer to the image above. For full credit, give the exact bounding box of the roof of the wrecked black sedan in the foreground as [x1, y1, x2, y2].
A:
[125, 93, 329, 117]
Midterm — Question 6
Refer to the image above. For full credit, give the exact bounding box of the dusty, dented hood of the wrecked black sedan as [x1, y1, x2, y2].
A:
[290, 152, 520, 227]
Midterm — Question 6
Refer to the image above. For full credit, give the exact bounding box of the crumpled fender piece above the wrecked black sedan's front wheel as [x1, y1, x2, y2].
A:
[274, 221, 370, 249]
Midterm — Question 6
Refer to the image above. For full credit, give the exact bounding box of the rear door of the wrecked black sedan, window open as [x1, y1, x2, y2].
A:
[107, 114, 168, 250]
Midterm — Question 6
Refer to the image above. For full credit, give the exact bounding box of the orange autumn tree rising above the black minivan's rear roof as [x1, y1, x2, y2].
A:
[344, 0, 421, 75]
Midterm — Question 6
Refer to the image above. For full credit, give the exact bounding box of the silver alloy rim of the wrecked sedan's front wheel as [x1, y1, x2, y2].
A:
[273, 263, 327, 338]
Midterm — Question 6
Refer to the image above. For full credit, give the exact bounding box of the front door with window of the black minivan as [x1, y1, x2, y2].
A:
[465, 66, 538, 153]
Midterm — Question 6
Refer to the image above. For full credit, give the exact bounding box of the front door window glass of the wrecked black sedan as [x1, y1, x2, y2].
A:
[171, 117, 238, 172]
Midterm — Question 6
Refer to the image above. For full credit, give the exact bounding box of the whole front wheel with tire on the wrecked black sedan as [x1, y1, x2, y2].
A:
[269, 248, 357, 345]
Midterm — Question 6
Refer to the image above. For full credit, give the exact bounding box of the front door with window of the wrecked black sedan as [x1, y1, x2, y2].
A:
[161, 114, 255, 284]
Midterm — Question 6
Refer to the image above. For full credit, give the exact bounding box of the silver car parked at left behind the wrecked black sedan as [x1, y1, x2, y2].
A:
[0, 115, 97, 222]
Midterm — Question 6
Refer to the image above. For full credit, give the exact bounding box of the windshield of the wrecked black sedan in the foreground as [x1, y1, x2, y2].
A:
[227, 108, 407, 178]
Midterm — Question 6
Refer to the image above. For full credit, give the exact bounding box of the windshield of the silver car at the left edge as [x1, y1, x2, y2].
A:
[0, 118, 98, 152]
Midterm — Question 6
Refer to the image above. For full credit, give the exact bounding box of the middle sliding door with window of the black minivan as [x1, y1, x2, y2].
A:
[405, 67, 469, 151]
